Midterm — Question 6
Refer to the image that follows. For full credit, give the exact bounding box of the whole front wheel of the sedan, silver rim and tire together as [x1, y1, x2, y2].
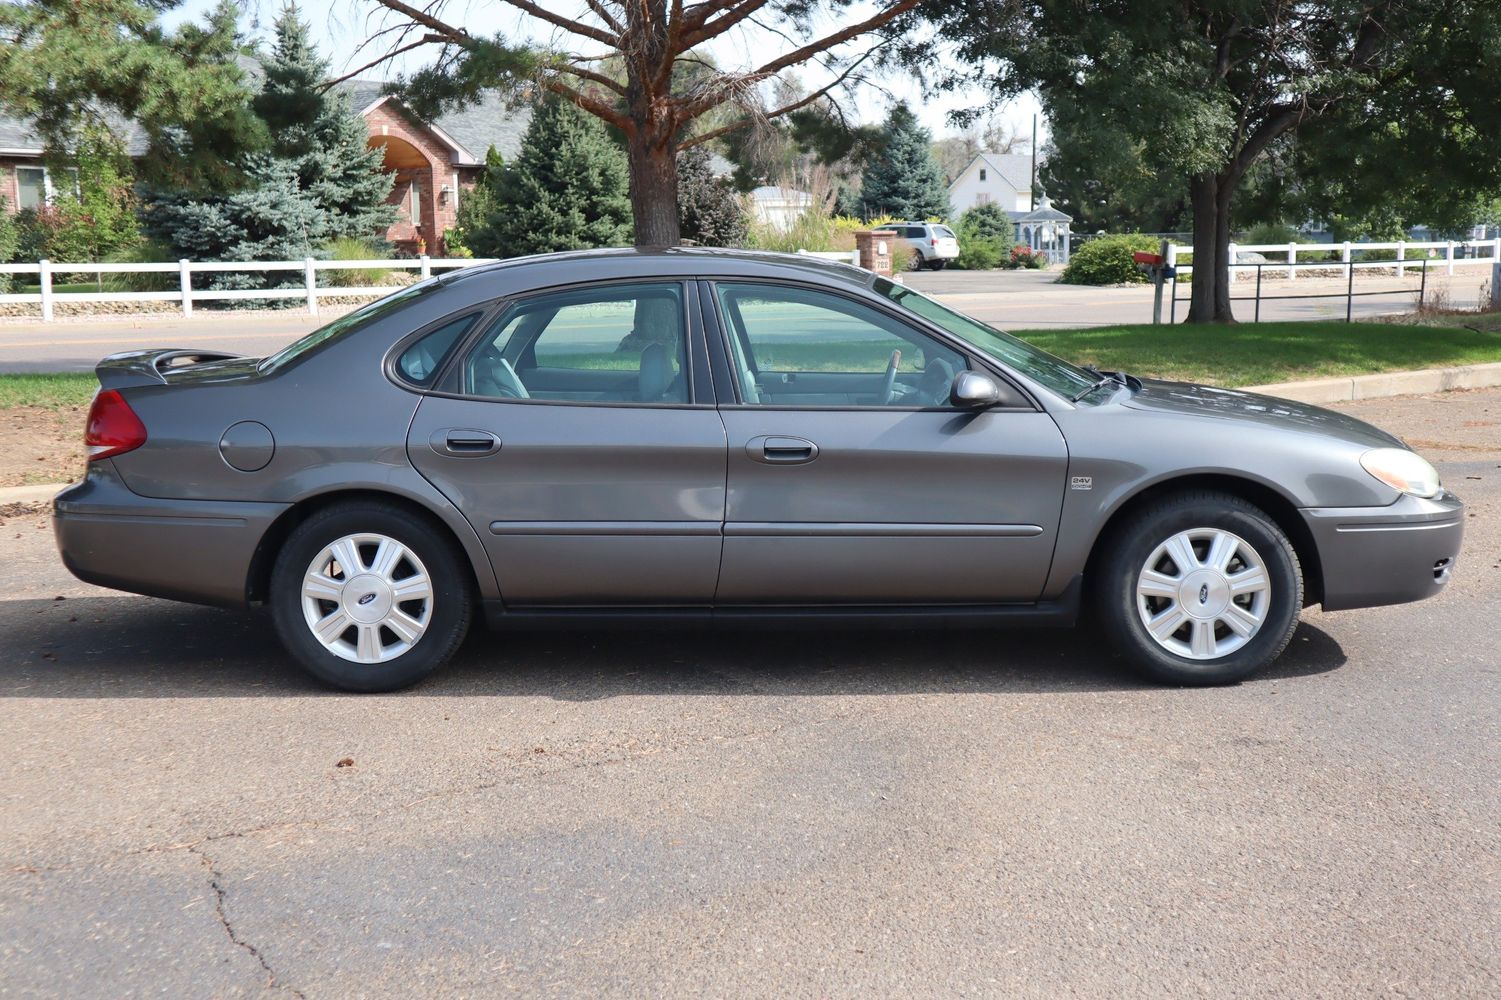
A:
[1096, 492, 1303, 685]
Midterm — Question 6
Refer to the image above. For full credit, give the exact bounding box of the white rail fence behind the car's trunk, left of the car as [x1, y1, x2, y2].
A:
[0, 257, 494, 323]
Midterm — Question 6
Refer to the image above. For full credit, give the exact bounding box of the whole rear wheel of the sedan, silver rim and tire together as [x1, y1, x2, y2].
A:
[270, 503, 473, 691]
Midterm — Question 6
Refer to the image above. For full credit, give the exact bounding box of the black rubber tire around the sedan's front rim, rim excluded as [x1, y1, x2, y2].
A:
[1094, 491, 1303, 686]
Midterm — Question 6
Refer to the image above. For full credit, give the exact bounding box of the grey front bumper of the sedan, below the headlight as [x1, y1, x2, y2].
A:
[1300, 491, 1465, 611]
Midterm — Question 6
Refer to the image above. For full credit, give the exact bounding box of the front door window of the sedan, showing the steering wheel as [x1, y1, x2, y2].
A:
[717, 282, 968, 407]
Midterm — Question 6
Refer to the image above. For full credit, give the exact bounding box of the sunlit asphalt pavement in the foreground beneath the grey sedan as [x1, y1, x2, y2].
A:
[0, 390, 1501, 998]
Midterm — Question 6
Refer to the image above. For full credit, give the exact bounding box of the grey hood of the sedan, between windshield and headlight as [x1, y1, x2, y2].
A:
[1121, 378, 1406, 447]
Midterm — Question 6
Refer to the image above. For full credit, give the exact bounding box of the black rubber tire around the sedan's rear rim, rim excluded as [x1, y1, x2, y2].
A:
[270, 502, 474, 692]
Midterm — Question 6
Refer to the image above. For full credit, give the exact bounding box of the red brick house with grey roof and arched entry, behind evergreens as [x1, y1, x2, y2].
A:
[0, 78, 531, 257]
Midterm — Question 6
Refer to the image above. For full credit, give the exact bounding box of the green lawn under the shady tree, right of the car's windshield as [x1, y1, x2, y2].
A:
[1012, 320, 1501, 386]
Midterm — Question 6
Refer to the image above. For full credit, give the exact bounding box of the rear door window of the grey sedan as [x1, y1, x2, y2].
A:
[464, 282, 687, 404]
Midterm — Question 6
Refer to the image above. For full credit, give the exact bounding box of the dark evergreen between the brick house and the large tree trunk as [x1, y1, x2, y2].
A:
[471, 98, 630, 257]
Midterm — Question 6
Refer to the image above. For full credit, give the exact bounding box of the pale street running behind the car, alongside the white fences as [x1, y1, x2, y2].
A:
[0, 267, 1489, 372]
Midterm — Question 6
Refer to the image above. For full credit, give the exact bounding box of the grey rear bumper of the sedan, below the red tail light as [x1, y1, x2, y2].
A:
[53, 459, 290, 607]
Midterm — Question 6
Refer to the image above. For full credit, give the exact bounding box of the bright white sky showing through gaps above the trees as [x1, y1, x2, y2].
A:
[155, 0, 1046, 141]
